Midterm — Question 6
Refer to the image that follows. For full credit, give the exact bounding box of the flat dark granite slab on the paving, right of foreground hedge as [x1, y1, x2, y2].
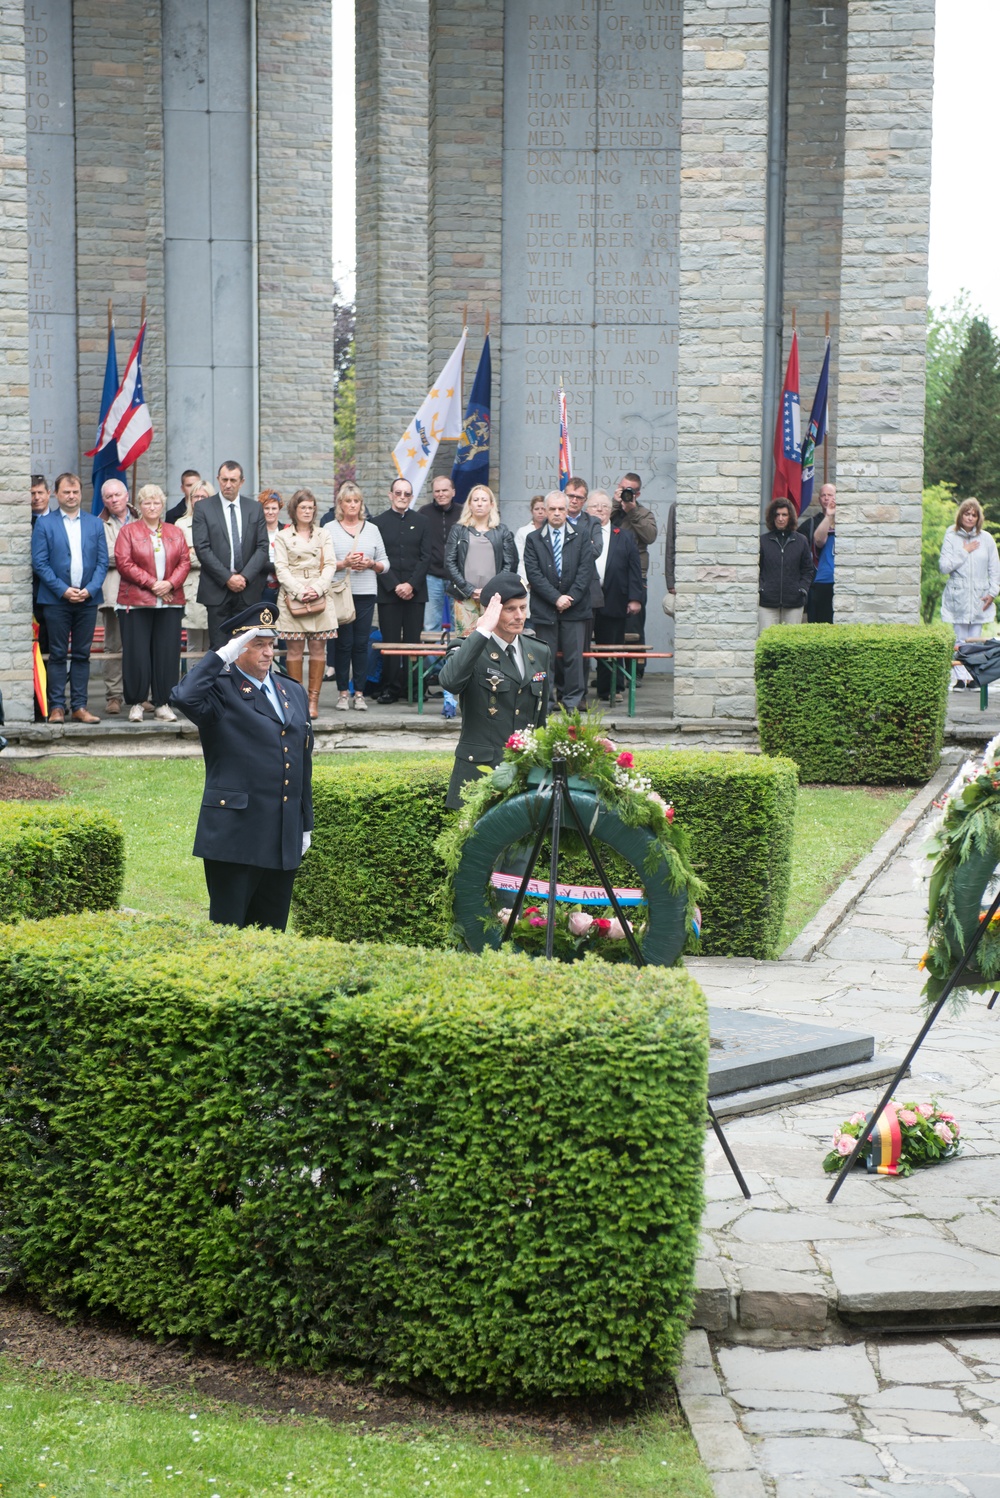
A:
[708, 1004, 874, 1098]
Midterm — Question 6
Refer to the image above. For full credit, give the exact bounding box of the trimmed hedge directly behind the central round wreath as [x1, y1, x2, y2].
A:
[293, 749, 796, 957]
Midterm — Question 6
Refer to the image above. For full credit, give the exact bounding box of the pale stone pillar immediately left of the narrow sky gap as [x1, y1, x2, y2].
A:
[257, 0, 334, 511]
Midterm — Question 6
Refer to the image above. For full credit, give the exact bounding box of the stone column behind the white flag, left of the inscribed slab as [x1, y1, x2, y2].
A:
[428, 0, 502, 485]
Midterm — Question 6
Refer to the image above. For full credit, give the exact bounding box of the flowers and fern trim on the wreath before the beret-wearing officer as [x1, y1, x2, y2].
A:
[437, 710, 705, 962]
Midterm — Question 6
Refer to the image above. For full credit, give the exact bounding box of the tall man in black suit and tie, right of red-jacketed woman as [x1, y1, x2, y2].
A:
[192, 458, 268, 650]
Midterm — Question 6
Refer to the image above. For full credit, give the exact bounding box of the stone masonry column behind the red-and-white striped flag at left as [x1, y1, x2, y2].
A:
[73, 0, 163, 496]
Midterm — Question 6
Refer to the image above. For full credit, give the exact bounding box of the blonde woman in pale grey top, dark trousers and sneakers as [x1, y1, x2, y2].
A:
[323, 481, 389, 713]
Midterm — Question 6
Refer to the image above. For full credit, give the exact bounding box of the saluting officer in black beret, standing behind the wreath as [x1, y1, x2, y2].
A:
[440, 572, 551, 810]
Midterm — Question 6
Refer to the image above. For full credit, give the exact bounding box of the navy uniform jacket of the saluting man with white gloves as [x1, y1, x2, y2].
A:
[171, 650, 313, 869]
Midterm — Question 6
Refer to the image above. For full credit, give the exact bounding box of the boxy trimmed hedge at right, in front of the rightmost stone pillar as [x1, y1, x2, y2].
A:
[756, 625, 955, 785]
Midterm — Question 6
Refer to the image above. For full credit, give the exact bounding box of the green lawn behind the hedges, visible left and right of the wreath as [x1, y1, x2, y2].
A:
[11, 753, 913, 947]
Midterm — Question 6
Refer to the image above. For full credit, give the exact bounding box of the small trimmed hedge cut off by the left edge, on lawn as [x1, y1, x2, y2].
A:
[0, 801, 124, 921]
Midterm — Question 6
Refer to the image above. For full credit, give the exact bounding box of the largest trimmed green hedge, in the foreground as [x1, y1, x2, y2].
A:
[0, 915, 708, 1398]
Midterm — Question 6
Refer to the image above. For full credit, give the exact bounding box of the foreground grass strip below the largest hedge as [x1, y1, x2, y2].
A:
[0, 1359, 713, 1498]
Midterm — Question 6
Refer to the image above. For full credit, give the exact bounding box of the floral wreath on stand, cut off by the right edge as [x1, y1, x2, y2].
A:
[919, 734, 1000, 1005]
